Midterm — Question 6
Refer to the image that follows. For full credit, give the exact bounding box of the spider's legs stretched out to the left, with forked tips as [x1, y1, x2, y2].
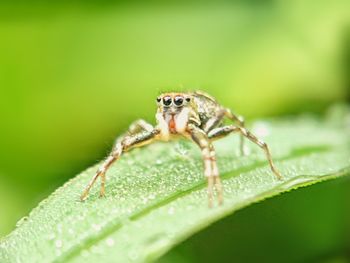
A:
[80, 120, 159, 201]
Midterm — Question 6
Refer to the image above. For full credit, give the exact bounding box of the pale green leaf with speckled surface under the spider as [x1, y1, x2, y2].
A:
[0, 114, 350, 262]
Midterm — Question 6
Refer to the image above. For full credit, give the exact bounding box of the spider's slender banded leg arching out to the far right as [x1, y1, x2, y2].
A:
[208, 125, 282, 180]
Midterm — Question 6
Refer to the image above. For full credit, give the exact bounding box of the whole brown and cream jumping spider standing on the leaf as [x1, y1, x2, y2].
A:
[81, 91, 282, 206]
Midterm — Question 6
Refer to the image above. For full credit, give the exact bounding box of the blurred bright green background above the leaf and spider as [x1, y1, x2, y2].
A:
[0, 0, 350, 262]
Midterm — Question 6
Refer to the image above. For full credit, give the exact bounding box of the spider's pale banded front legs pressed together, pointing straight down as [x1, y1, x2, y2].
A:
[188, 124, 223, 207]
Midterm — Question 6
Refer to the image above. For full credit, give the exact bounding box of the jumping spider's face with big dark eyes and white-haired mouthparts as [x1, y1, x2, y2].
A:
[156, 93, 192, 137]
